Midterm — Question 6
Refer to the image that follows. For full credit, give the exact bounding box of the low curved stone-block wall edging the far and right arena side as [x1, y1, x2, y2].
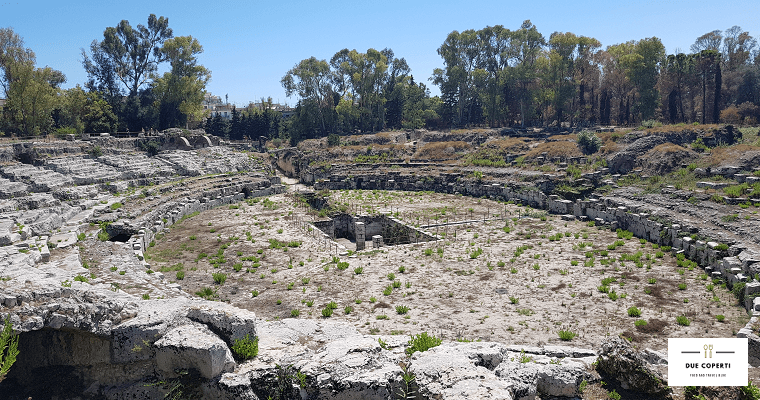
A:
[314, 172, 760, 311]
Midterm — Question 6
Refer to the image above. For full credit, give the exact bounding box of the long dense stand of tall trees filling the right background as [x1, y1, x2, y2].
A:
[432, 21, 760, 126]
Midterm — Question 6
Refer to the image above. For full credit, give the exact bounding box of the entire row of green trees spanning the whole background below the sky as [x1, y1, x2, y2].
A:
[0, 14, 760, 144]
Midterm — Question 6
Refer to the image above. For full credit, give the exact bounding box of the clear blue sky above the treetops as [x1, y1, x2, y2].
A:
[0, 0, 760, 105]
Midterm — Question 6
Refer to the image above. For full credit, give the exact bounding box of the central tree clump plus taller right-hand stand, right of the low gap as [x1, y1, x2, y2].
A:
[281, 21, 760, 139]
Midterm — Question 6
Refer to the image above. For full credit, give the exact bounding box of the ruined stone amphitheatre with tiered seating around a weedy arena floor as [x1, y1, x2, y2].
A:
[0, 126, 760, 399]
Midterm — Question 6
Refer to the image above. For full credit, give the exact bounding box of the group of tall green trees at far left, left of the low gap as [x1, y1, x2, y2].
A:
[0, 14, 211, 136]
